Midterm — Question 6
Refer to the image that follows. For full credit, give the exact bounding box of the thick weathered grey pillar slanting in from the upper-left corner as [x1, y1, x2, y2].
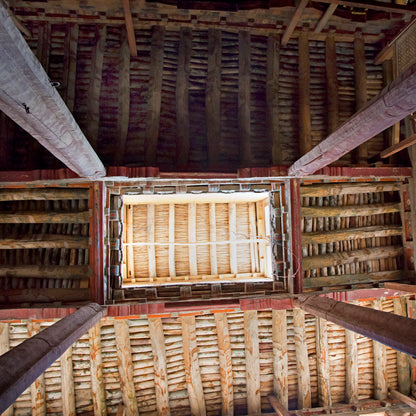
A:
[0, 5, 105, 179]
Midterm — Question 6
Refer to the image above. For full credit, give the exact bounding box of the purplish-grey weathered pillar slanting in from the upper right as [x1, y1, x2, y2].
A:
[289, 60, 416, 176]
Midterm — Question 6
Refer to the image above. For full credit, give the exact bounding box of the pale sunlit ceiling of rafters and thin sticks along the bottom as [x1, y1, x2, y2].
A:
[0, 298, 414, 416]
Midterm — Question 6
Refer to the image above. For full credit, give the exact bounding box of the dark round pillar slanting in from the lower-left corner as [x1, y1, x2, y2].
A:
[0, 304, 106, 413]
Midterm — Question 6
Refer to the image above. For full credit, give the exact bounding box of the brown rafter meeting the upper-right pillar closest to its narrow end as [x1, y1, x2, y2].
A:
[299, 28, 312, 156]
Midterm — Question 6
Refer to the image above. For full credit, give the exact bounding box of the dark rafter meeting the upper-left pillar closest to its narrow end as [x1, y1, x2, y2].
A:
[85, 25, 107, 148]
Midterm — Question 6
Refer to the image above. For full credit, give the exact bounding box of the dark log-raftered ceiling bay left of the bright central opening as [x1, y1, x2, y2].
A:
[0, 187, 90, 305]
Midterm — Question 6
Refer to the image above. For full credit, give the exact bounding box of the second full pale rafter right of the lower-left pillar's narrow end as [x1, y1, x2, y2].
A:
[149, 318, 170, 416]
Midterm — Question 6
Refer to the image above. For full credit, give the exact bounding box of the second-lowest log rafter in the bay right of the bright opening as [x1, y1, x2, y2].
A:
[302, 246, 403, 270]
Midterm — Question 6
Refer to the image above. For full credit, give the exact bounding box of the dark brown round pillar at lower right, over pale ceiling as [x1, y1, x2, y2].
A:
[297, 296, 416, 356]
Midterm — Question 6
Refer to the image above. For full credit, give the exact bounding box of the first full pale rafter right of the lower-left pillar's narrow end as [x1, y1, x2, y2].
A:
[114, 319, 139, 416]
